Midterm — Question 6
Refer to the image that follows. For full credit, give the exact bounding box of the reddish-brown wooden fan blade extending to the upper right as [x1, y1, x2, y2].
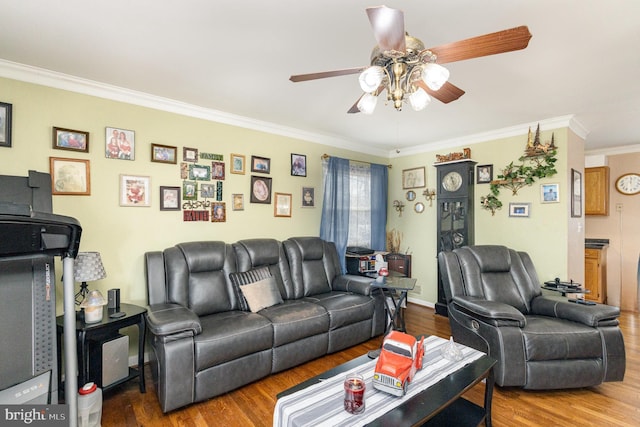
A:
[428, 25, 531, 64]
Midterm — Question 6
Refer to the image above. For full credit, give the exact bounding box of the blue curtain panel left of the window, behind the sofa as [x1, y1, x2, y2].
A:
[320, 156, 349, 272]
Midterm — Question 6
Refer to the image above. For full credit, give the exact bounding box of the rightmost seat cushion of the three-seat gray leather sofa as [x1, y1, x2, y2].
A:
[305, 291, 375, 330]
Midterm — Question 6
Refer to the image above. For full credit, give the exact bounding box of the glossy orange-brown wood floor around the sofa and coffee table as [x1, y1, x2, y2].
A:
[102, 304, 640, 427]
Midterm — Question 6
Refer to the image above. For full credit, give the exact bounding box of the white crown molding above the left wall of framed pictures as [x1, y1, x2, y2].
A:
[0, 59, 387, 157]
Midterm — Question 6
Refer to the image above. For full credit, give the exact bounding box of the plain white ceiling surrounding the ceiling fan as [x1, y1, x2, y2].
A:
[0, 0, 640, 156]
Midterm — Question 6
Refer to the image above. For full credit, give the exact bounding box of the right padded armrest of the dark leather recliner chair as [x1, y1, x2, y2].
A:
[531, 296, 620, 327]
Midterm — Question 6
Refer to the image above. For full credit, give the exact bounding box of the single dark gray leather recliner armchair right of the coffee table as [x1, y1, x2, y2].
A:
[438, 245, 626, 389]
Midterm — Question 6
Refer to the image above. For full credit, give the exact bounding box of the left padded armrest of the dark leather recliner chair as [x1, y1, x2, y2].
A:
[452, 295, 527, 327]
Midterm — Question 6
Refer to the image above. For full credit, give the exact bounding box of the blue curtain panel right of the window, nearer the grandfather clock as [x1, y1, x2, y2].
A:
[371, 164, 389, 251]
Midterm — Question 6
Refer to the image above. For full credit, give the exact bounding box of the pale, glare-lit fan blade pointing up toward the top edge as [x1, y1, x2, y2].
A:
[367, 6, 406, 52]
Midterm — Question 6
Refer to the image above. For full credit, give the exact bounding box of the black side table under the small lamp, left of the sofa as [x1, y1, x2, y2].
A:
[56, 304, 147, 398]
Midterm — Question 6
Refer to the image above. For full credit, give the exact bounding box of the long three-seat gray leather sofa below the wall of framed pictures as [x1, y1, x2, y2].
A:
[145, 237, 385, 412]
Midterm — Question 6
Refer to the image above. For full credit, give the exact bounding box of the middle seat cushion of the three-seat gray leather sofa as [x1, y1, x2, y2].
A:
[260, 300, 329, 347]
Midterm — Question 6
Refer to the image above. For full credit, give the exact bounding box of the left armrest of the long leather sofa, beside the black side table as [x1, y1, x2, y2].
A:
[147, 304, 202, 336]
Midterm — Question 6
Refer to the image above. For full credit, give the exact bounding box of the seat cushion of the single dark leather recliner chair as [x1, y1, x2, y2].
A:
[522, 316, 603, 361]
